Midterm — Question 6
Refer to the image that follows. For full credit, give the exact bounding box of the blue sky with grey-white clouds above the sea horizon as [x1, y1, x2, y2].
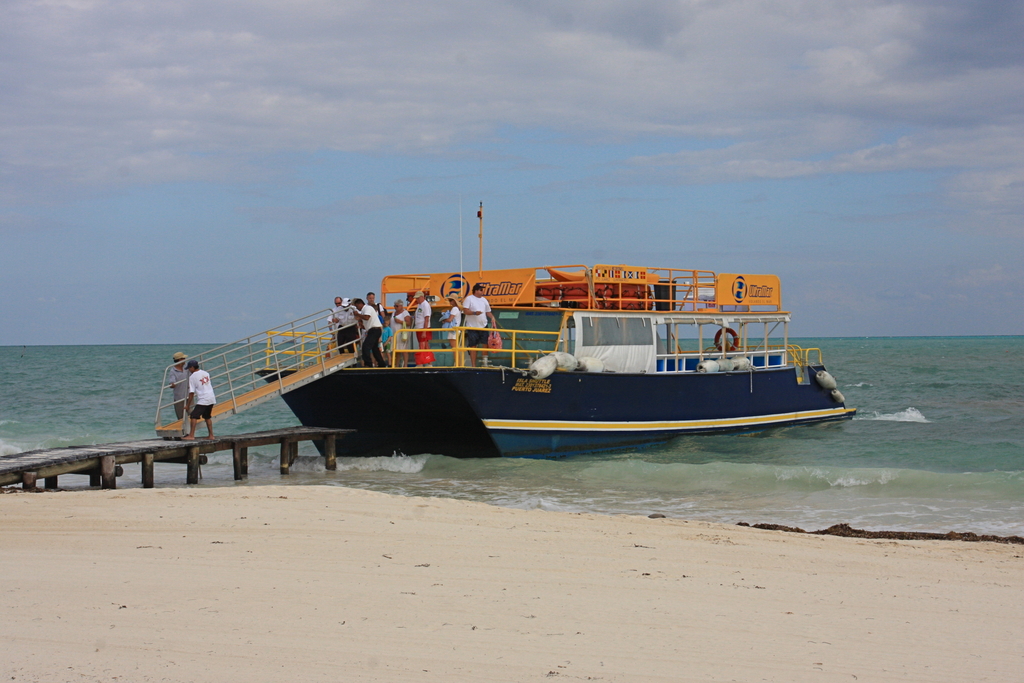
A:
[0, 0, 1024, 345]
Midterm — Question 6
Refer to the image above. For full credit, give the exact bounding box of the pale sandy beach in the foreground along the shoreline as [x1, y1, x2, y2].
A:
[0, 486, 1024, 683]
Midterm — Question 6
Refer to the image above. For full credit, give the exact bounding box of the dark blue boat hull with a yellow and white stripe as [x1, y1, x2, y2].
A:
[284, 367, 854, 458]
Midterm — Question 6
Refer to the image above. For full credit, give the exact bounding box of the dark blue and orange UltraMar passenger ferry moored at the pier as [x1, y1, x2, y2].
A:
[272, 265, 856, 458]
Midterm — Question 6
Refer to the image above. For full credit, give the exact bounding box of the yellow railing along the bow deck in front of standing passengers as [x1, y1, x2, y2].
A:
[390, 328, 561, 368]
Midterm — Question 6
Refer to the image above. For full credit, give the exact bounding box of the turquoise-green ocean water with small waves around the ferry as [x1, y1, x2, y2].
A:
[0, 337, 1024, 536]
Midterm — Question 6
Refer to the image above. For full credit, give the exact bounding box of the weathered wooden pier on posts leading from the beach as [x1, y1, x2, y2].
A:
[0, 427, 351, 489]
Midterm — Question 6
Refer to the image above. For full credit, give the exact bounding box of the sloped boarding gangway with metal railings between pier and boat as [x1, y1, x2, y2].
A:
[156, 310, 356, 437]
